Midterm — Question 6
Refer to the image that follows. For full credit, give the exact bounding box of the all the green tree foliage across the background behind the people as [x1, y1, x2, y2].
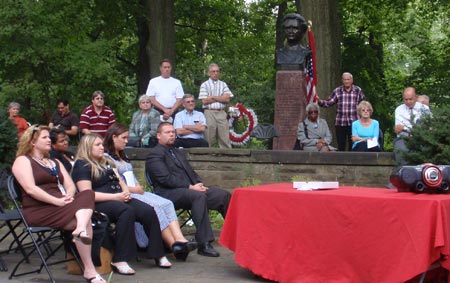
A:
[0, 0, 450, 154]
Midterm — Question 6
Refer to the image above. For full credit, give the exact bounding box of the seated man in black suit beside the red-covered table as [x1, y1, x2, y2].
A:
[145, 122, 231, 257]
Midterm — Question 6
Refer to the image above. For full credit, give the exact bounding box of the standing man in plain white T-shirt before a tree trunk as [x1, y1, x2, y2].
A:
[146, 59, 184, 121]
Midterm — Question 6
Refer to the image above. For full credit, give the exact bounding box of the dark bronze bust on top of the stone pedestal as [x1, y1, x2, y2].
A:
[276, 13, 311, 70]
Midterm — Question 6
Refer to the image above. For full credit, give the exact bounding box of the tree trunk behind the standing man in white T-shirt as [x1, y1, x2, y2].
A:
[138, 0, 175, 93]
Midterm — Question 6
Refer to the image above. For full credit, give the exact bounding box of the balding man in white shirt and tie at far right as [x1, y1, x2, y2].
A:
[394, 87, 430, 165]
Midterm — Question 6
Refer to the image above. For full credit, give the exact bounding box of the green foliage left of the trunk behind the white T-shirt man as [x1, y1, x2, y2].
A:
[0, 0, 136, 124]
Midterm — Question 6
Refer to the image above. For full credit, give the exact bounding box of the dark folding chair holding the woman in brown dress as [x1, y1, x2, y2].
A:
[7, 176, 83, 282]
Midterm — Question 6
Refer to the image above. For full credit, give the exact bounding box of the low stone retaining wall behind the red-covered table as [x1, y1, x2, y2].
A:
[121, 148, 395, 190]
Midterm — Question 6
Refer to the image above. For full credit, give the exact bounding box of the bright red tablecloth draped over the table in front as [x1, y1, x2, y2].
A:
[219, 183, 450, 283]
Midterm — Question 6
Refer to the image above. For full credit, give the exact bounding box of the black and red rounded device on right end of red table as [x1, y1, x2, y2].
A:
[389, 163, 450, 194]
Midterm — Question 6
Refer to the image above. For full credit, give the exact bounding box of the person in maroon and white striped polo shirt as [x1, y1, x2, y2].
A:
[80, 90, 116, 137]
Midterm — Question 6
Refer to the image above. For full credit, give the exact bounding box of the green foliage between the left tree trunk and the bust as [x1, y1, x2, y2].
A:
[175, 0, 275, 121]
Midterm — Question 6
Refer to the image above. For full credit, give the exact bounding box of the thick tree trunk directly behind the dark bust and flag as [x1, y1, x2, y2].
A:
[298, 0, 342, 146]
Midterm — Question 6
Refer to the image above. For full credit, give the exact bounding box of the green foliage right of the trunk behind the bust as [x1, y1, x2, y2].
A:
[340, 0, 450, 147]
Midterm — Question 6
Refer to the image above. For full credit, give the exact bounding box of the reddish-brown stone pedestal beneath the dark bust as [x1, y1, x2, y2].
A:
[273, 71, 306, 150]
